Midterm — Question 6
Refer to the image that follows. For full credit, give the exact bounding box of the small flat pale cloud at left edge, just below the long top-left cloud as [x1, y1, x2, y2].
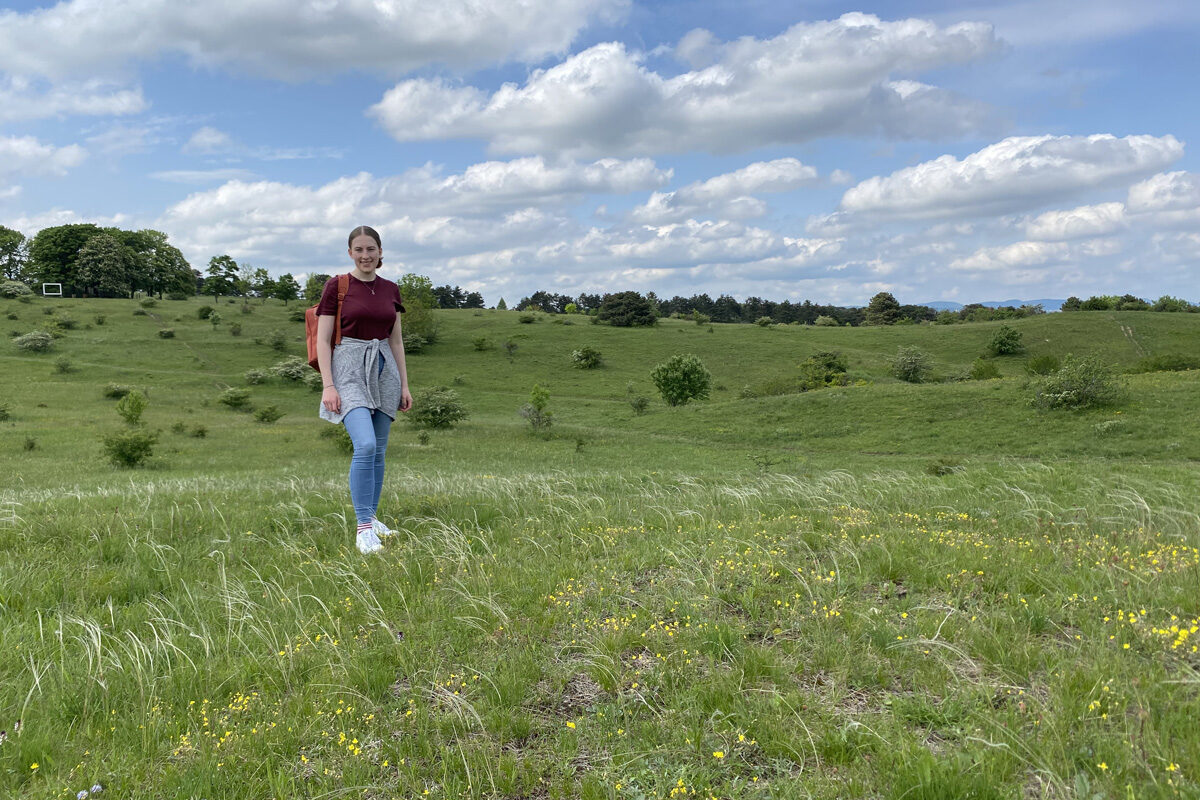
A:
[0, 75, 146, 124]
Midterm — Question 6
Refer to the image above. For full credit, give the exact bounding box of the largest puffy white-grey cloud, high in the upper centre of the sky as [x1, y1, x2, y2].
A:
[370, 13, 1001, 156]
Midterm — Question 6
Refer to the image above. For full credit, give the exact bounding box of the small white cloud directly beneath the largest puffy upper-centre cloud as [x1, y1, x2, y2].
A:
[630, 158, 817, 223]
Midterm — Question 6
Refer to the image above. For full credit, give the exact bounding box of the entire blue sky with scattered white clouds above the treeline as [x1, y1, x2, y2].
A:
[0, 0, 1200, 305]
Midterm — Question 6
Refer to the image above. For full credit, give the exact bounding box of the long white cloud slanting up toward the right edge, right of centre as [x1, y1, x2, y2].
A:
[829, 134, 1183, 223]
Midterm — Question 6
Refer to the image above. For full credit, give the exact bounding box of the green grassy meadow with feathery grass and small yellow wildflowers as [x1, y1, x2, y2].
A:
[0, 299, 1200, 800]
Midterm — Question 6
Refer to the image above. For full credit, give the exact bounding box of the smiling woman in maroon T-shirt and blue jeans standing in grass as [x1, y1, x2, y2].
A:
[317, 225, 413, 553]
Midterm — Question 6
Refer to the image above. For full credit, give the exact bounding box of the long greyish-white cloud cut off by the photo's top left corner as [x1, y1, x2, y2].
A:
[0, 0, 628, 79]
